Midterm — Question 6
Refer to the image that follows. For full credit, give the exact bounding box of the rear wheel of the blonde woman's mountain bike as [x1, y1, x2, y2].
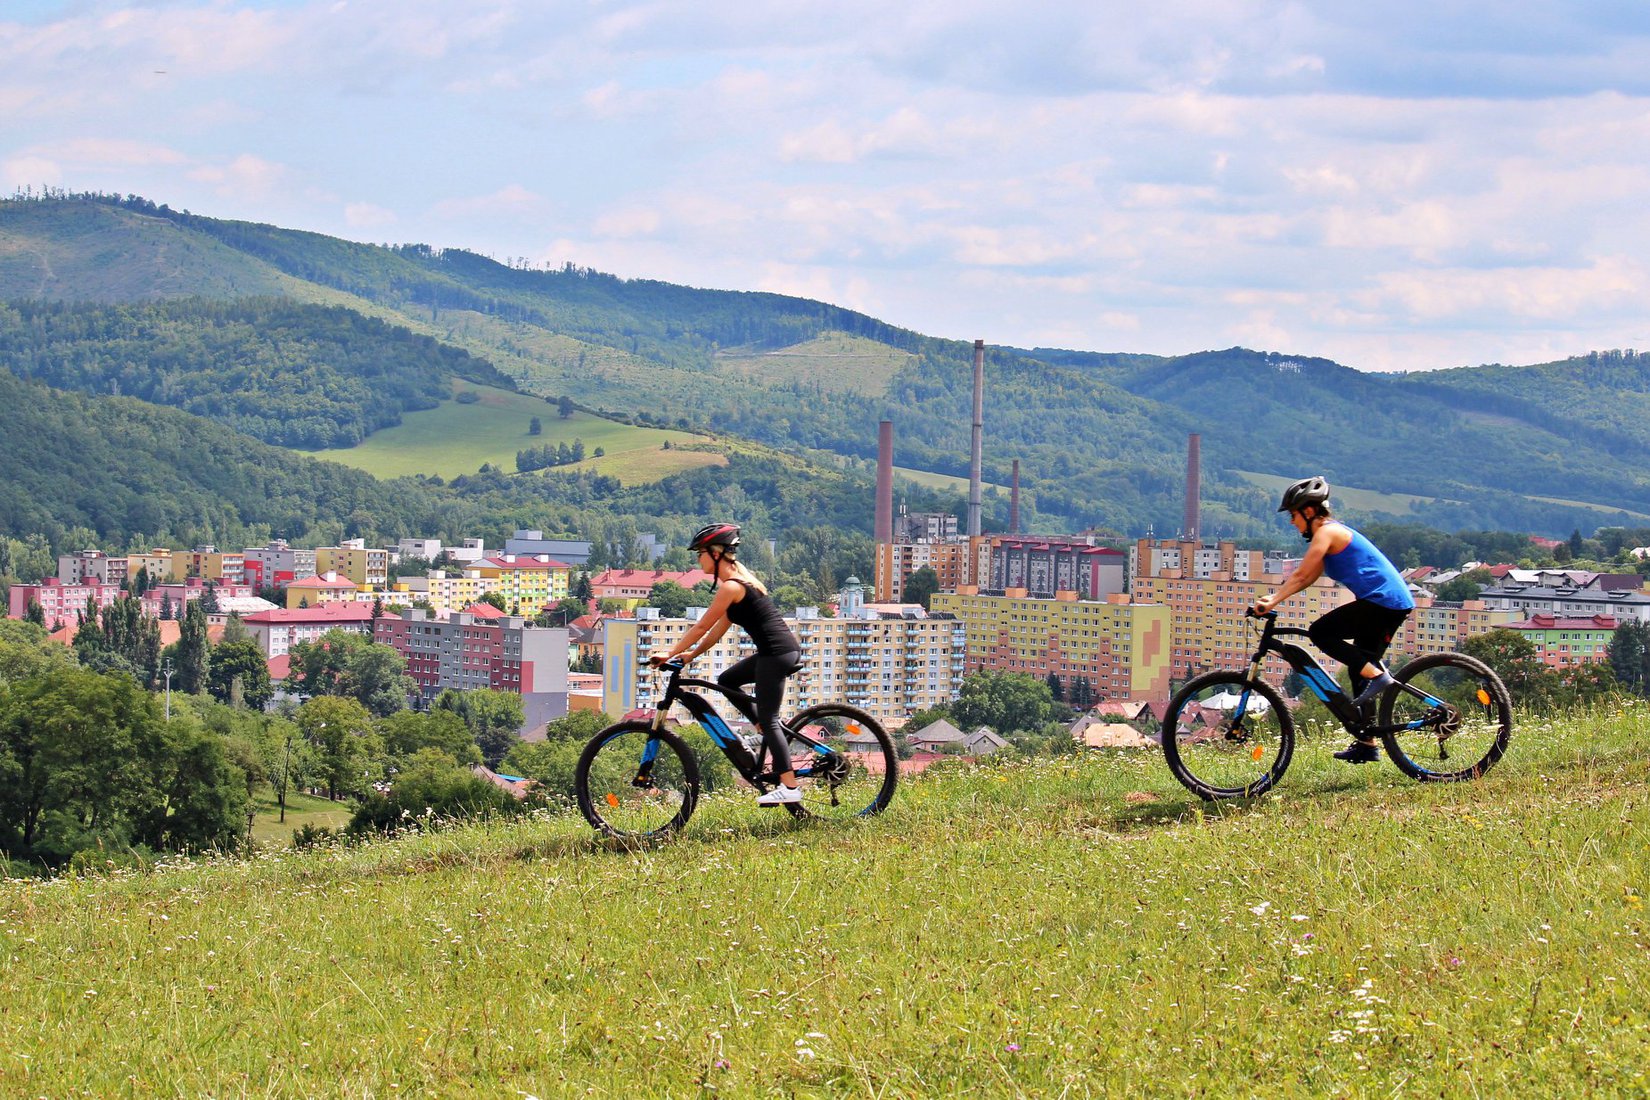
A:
[785, 703, 899, 818]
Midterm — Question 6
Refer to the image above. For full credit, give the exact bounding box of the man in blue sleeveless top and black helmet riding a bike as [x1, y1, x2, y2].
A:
[1254, 477, 1416, 764]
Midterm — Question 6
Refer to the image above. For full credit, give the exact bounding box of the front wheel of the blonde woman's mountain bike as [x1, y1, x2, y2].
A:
[573, 722, 700, 839]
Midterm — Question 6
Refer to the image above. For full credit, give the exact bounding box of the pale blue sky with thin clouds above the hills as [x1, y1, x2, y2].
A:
[0, 0, 1650, 369]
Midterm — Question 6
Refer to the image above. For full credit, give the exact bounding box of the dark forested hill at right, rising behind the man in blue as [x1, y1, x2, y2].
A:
[1023, 348, 1650, 531]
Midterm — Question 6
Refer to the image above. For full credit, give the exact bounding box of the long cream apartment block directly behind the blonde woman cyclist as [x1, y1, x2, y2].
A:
[601, 607, 964, 729]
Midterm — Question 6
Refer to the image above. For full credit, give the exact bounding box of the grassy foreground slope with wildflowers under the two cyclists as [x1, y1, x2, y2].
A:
[0, 706, 1650, 1097]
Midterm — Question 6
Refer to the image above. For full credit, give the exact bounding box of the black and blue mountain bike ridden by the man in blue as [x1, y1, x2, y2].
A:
[1162, 612, 1513, 801]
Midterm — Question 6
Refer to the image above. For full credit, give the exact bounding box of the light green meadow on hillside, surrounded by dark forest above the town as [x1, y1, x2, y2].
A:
[307, 379, 703, 480]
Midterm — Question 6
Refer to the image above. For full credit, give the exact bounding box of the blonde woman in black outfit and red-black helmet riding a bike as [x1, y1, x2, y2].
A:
[648, 523, 802, 806]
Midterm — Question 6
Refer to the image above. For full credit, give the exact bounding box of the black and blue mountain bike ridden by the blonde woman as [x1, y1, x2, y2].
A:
[573, 661, 899, 839]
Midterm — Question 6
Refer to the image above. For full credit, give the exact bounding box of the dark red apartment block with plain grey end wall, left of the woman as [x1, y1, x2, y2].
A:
[373, 610, 568, 739]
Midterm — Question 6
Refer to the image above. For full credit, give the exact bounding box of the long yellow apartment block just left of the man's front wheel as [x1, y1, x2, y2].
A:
[929, 590, 1173, 699]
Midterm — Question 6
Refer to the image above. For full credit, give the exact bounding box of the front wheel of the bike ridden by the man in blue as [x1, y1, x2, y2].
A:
[1162, 671, 1295, 801]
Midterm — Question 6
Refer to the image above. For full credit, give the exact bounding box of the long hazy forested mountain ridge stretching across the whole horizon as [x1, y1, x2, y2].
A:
[0, 196, 1650, 534]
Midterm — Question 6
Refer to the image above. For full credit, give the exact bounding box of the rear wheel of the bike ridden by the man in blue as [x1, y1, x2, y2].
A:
[1378, 653, 1513, 783]
